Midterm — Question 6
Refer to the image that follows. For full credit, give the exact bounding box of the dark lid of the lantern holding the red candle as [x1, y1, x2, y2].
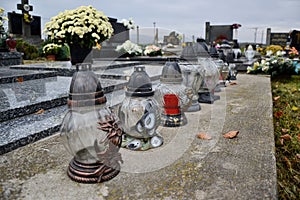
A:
[160, 62, 183, 83]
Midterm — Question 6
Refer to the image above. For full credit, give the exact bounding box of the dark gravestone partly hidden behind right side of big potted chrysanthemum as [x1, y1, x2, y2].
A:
[93, 17, 129, 59]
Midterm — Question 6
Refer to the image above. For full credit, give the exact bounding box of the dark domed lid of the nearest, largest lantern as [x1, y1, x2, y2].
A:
[68, 63, 106, 107]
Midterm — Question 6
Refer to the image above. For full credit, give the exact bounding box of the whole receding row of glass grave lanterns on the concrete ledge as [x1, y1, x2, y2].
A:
[61, 43, 229, 183]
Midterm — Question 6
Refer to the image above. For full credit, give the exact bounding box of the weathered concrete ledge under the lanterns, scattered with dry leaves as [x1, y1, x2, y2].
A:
[0, 74, 277, 200]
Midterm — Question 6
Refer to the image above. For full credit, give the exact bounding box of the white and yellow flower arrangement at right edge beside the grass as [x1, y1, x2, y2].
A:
[247, 51, 296, 77]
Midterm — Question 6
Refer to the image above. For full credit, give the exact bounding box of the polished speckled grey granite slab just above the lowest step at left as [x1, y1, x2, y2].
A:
[0, 76, 127, 122]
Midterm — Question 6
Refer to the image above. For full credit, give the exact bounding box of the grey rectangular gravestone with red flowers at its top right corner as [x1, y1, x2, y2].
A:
[205, 22, 233, 44]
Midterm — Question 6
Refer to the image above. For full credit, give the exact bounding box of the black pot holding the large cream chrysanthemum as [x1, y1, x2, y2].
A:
[70, 45, 92, 65]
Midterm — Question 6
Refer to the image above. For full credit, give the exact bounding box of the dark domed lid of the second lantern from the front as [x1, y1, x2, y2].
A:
[125, 66, 154, 97]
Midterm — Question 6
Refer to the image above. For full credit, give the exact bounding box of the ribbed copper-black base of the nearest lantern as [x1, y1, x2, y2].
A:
[67, 159, 120, 183]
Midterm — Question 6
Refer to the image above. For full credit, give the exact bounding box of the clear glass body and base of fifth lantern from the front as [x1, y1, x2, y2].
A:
[198, 57, 220, 104]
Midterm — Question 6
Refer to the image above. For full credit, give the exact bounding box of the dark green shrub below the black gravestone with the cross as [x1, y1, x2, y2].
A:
[16, 39, 39, 60]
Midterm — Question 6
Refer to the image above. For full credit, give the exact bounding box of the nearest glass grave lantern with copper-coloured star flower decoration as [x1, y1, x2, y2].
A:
[60, 63, 123, 183]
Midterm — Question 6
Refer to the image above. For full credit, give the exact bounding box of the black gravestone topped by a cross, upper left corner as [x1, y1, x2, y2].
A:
[8, 0, 42, 44]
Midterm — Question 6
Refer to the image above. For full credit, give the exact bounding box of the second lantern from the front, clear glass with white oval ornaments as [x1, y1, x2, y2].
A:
[119, 66, 163, 150]
